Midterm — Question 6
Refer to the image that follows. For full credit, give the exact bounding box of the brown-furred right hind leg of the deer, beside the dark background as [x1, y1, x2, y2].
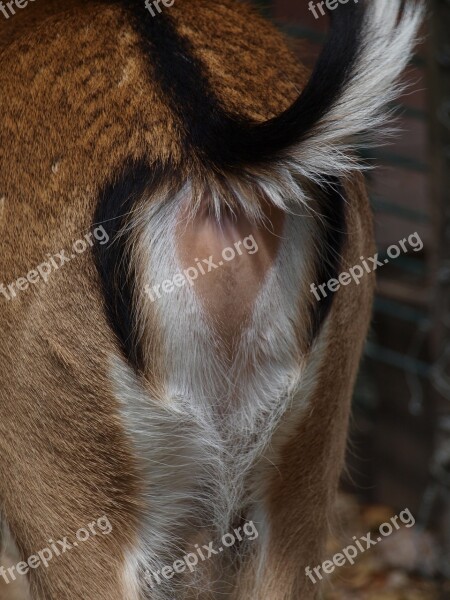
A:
[232, 188, 374, 600]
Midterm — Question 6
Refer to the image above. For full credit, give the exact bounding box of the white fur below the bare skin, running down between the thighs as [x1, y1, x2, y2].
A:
[111, 190, 328, 600]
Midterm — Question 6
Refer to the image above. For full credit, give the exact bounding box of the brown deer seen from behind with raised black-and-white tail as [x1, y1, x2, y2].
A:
[0, 0, 424, 600]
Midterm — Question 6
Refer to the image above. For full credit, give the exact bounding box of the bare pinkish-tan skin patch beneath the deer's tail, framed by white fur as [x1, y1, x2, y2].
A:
[177, 204, 284, 350]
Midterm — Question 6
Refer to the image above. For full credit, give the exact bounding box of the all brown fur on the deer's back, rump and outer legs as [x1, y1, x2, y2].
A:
[0, 0, 372, 600]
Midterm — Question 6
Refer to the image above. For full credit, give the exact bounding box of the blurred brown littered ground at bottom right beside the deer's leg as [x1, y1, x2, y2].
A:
[325, 496, 450, 600]
